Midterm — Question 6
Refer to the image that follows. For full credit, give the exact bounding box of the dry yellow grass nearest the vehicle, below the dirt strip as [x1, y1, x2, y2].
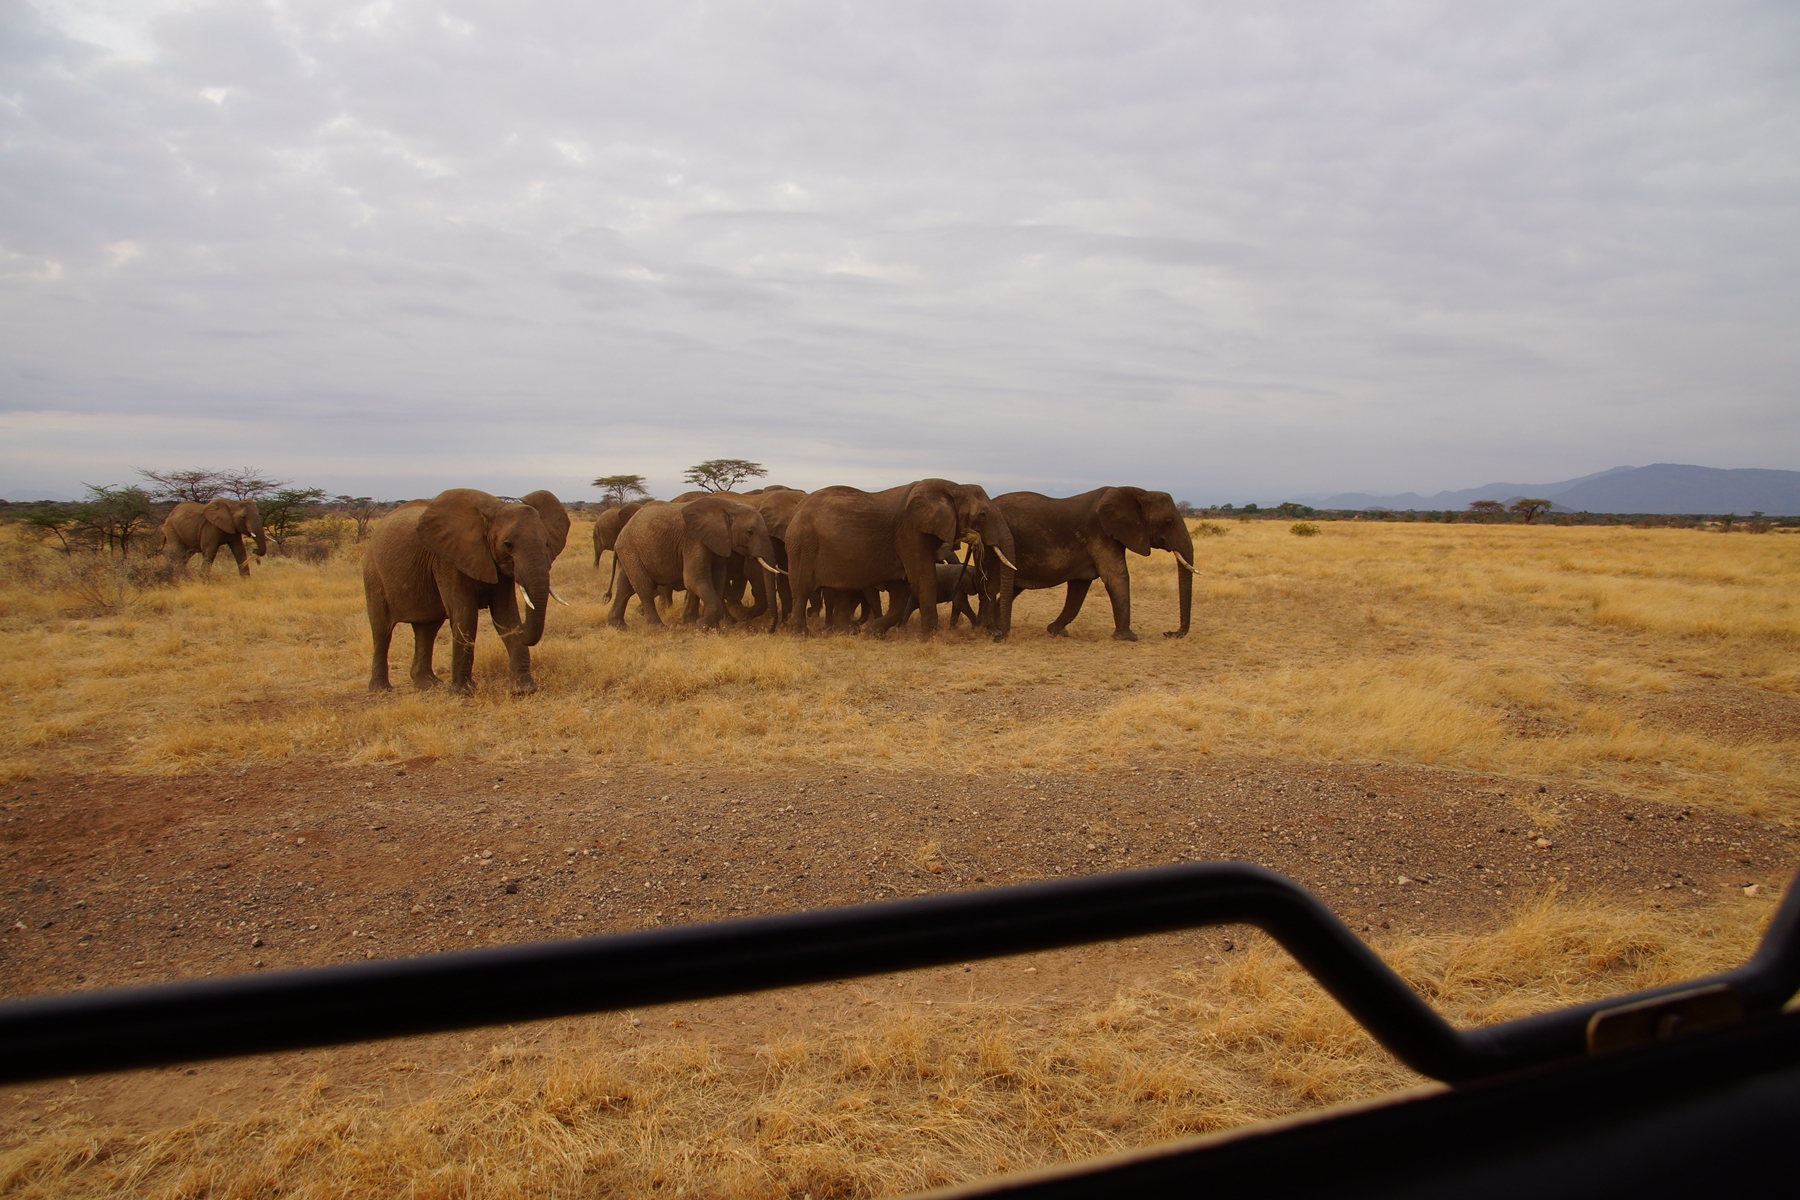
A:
[0, 898, 1773, 1200]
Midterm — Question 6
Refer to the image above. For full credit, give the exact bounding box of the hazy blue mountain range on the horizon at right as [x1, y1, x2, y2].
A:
[1318, 462, 1800, 516]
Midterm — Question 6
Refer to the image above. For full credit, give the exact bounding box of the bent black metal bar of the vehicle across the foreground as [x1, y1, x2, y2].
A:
[0, 862, 1800, 1083]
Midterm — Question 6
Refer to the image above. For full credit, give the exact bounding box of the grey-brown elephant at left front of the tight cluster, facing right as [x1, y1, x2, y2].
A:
[607, 493, 776, 630]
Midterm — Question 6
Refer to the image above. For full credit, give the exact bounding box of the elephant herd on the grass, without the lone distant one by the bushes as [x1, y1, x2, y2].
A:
[349, 479, 1193, 693]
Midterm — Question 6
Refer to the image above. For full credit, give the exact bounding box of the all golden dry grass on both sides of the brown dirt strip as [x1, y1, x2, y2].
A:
[0, 522, 1800, 1198]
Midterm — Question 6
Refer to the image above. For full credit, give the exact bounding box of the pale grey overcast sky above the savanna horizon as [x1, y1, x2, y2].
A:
[0, 0, 1800, 504]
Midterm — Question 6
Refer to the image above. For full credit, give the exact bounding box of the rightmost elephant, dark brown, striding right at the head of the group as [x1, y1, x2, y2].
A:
[994, 488, 1193, 642]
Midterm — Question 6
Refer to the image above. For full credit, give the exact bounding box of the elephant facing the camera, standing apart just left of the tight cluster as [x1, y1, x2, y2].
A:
[362, 488, 569, 696]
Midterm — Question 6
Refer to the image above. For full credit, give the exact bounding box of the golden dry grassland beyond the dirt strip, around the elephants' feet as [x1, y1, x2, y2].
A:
[0, 522, 1800, 819]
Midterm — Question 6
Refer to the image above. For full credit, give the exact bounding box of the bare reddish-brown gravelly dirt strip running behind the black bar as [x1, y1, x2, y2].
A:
[0, 756, 1800, 1124]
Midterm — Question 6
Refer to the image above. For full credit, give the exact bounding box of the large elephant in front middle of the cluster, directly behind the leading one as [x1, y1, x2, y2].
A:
[787, 479, 1013, 640]
